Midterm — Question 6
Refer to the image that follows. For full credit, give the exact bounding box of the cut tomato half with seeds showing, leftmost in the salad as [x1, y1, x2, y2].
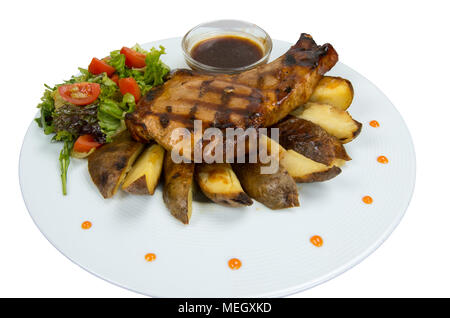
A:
[58, 82, 100, 106]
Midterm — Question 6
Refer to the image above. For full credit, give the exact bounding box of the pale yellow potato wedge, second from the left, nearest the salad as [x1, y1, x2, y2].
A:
[122, 144, 164, 195]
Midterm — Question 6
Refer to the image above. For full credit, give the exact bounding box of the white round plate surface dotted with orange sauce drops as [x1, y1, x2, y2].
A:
[19, 38, 415, 297]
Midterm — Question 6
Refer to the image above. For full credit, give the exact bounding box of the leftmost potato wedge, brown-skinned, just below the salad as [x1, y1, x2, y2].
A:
[88, 132, 144, 199]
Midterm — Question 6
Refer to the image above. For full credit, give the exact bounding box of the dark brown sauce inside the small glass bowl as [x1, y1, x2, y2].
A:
[191, 35, 264, 68]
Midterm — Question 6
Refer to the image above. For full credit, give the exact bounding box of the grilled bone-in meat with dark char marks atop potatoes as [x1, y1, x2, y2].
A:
[126, 34, 338, 158]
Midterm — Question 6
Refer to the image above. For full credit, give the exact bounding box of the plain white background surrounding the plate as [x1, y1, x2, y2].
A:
[0, 0, 450, 297]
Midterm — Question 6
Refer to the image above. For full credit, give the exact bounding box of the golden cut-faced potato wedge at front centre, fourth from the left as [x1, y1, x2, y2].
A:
[195, 163, 253, 207]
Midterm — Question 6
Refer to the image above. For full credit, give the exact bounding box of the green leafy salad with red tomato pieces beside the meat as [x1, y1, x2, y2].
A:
[36, 45, 169, 195]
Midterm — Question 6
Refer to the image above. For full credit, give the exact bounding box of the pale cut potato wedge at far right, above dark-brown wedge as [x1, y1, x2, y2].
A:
[291, 102, 362, 144]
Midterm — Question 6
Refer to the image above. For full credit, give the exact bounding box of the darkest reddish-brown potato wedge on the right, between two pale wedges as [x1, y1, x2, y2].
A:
[274, 116, 351, 166]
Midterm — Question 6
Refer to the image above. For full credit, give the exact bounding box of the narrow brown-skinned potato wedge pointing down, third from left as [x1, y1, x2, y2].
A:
[163, 154, 194, 224]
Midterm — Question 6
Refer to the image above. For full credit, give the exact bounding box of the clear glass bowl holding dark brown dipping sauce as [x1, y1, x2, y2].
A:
[182, 20, 272, 74]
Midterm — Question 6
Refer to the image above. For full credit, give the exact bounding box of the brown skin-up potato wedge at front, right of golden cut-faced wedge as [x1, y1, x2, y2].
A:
[233, 163, 299, 210]
